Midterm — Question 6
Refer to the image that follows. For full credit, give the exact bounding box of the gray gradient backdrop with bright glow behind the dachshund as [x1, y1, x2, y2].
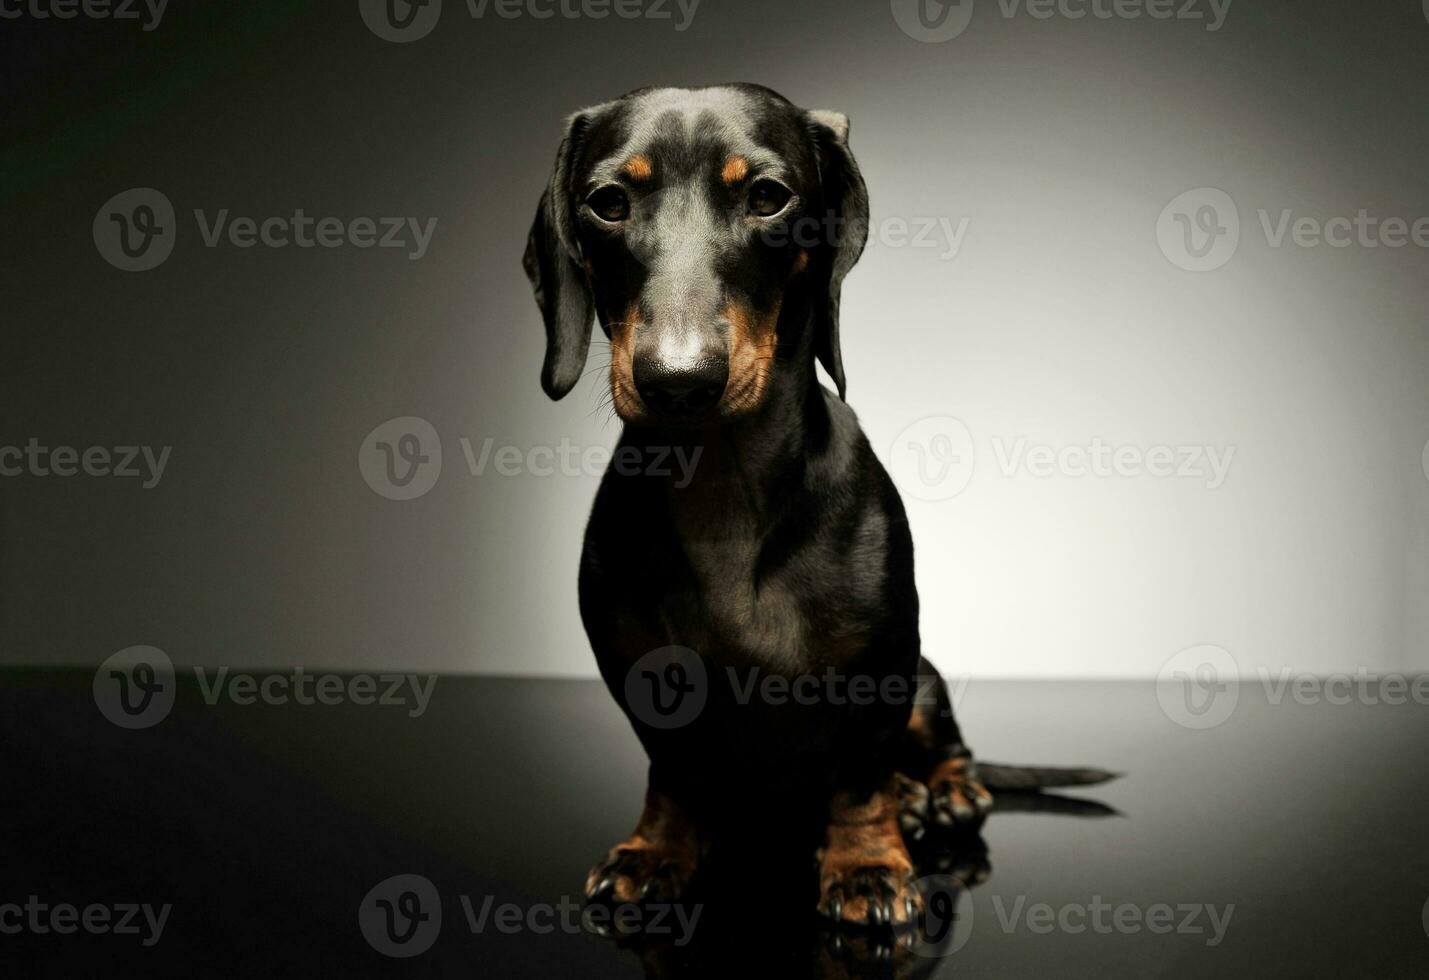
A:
[0, 0, 1429, 676]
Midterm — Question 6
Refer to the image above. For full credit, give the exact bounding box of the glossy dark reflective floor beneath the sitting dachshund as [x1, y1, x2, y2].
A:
[0, 671, 1429, 977]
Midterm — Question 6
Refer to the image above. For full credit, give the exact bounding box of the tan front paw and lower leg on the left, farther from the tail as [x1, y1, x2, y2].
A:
[586, 767, 700, 903]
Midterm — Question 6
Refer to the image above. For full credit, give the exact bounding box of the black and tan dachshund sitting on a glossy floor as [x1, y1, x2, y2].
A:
[526, 84, 1105, 926]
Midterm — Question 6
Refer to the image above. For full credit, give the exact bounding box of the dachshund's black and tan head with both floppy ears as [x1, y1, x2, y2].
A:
[524, 84, 869, 423]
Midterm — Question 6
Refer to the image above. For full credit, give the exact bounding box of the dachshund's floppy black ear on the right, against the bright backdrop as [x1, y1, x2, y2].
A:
[807, 110, 869, 399]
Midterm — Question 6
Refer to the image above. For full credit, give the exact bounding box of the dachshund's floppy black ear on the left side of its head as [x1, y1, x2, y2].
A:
[522, 110, 596, 399]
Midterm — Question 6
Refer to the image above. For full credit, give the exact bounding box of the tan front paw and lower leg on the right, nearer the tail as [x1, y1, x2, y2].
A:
[819, 776, 923, 926]
